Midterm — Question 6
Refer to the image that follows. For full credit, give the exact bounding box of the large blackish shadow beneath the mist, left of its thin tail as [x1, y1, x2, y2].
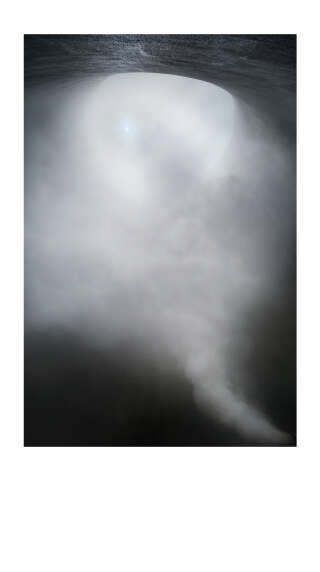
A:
[25, 330, 241, 446]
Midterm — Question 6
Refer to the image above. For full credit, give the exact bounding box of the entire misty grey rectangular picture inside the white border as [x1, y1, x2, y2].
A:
[25, 35, 296, 446]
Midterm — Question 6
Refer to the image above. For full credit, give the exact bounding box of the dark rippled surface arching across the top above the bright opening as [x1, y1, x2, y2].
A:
[25, 34, 296, 135]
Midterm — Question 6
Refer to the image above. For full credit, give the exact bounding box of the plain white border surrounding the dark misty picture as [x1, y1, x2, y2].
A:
[0, 1, 320, 572]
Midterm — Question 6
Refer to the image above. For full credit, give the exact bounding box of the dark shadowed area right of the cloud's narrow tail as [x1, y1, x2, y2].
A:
[229, 256, 297, 446]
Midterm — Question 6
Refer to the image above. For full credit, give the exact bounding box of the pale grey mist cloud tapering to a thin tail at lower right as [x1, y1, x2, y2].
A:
[25, 73, 294, 443]
